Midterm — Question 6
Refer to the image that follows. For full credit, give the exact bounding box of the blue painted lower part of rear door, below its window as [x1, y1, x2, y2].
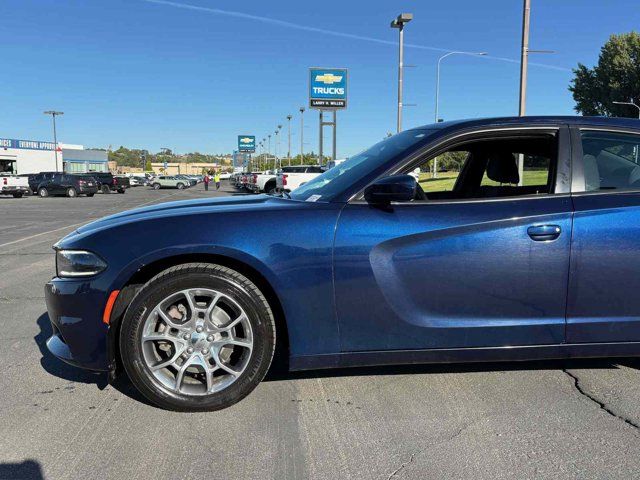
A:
[567, 192, 640, 343]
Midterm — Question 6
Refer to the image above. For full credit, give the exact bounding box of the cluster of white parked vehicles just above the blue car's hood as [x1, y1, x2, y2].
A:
[229, 165, 327, 194]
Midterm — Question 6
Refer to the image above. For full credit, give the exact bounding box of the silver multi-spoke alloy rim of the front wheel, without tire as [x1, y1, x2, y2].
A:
[141, 288, 253, 395]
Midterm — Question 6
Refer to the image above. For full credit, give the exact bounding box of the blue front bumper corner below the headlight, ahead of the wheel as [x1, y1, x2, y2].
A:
[44, 278, 109, 371]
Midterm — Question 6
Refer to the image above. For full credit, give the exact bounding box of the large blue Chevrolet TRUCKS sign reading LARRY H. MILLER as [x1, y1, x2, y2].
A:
[309, 67, 347, 110]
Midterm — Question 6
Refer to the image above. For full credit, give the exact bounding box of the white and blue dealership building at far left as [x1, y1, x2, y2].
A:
[0, 138, 109, 175]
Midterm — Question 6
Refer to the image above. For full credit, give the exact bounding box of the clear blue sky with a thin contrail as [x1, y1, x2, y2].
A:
[0, 0, 640, 157]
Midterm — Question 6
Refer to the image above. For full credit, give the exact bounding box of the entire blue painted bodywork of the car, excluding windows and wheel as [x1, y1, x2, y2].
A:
[45, 117, 640, 370]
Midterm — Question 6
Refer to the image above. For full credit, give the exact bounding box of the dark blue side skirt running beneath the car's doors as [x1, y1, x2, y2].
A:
[289, 342, 640, 371]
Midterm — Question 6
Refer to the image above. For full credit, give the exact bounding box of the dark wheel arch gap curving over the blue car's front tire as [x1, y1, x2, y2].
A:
[107, 253, 289, 379]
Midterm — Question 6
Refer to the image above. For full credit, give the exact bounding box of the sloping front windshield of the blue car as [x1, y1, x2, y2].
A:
[291, 129, 433, 202]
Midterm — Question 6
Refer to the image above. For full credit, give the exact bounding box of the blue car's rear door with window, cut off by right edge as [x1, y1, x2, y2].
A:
[567, 127, 640, 343]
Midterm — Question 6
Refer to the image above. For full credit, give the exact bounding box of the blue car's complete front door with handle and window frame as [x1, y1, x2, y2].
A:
[334, 127, 572, 352]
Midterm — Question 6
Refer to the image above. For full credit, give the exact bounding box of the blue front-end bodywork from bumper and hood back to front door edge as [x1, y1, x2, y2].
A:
[47, 195, 342, 369]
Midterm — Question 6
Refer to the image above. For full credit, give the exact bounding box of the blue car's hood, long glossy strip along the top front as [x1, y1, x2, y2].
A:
[74, 195, 290, 234]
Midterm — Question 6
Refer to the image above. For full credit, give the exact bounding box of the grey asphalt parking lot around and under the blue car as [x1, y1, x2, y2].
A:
[0, 182, 640, 480]
